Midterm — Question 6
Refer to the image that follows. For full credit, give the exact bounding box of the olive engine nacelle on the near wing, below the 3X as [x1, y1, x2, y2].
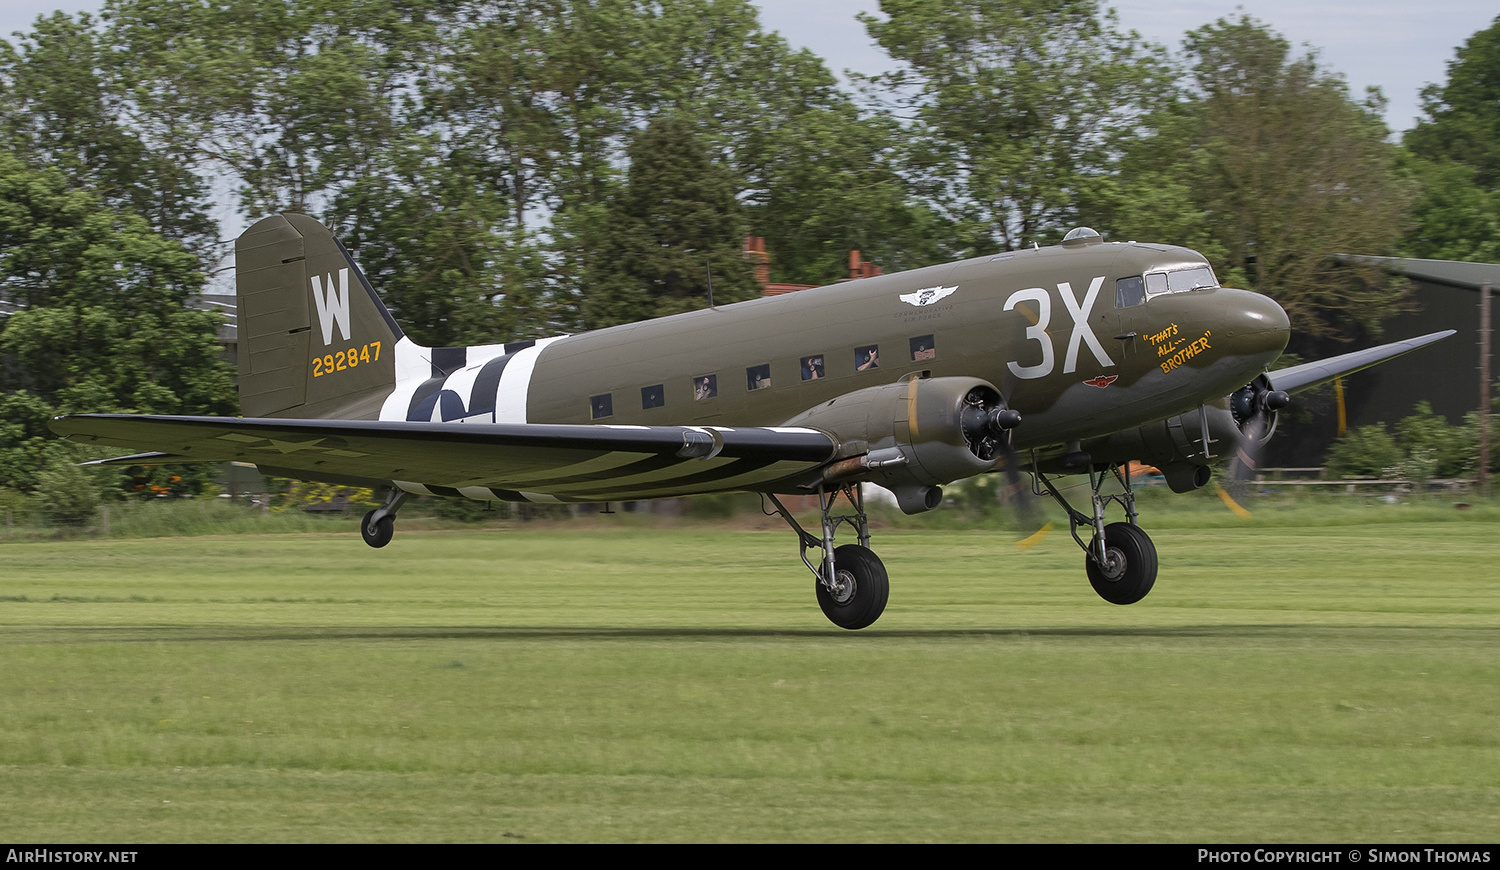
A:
[786, 378, 1020, 513]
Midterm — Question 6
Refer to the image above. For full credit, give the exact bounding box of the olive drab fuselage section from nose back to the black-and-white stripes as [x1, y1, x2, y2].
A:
[525, 242, 1287, 449]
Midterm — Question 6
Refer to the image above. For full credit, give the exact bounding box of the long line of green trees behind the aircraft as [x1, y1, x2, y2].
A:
[0, 0, 1500, 501]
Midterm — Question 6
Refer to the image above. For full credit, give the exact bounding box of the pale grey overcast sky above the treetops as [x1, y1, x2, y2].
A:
[0, 0, 1497, 132]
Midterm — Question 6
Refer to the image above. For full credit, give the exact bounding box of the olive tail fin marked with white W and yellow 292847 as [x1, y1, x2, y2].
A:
[234, 215, 404, 420]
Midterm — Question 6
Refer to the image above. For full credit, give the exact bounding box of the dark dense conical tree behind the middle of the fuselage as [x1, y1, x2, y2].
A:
[585, 117, 756, 329]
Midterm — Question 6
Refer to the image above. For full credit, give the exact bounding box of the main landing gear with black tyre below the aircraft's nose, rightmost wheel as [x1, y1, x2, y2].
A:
[1032, 464, 1157, 605]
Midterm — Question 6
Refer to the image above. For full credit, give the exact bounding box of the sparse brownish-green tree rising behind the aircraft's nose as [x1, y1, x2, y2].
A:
[1109, 17, 1410, 335]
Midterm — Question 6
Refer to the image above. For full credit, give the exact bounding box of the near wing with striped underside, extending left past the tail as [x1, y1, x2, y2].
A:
[51, 414, 837, 501]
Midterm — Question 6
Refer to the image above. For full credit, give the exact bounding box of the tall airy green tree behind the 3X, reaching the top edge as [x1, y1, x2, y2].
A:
[861, 0, 1170, 254]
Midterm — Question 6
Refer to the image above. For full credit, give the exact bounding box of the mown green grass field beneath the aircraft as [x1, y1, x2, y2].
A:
[0, 509, 1500, 843]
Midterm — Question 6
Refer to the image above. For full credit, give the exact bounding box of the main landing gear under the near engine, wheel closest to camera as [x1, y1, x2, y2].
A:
[767, 483, 891, 629]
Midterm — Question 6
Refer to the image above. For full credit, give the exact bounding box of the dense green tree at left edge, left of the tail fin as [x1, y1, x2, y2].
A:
[0, 152, 236, 488]
